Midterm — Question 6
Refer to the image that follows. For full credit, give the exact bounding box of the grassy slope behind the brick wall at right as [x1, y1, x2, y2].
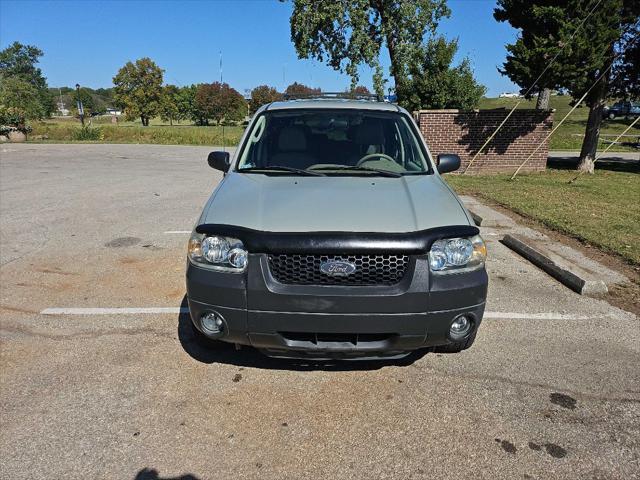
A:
[480, 95, 640, 152]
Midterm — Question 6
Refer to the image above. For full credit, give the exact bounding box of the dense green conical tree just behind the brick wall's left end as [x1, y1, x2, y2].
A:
[398, 36, 486, 111]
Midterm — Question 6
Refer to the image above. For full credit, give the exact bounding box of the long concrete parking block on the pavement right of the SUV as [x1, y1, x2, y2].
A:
[501, 234, 609, 295]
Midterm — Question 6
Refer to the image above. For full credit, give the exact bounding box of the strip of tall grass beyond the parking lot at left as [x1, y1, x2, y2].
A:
[29, 117, 244, 146]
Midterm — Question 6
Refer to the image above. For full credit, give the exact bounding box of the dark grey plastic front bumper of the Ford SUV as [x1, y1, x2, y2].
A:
[187, 254, 488, 359]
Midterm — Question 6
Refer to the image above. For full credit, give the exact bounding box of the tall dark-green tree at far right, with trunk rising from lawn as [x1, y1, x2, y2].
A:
[494, 0, 640, 173]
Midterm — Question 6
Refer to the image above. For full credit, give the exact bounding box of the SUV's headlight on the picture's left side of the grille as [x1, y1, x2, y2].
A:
[189, 233, 249, 272]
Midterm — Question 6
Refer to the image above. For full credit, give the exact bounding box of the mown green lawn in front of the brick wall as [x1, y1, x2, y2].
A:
[446, 170, 640, 265]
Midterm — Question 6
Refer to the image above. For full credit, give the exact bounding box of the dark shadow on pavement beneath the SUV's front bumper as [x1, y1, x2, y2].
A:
[178, 296, 429, 371]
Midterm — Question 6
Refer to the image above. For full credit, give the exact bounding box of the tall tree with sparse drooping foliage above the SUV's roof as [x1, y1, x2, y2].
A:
[290, 0, 450, 99]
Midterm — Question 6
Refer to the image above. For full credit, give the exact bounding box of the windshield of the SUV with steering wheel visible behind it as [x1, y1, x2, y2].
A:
[237, 109, 428, 176]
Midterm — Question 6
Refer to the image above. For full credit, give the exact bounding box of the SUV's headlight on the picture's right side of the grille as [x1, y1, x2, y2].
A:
[429, 235, 487, 273]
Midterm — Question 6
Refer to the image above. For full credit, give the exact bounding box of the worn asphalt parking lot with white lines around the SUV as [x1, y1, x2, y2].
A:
[0, 144, 640, 479]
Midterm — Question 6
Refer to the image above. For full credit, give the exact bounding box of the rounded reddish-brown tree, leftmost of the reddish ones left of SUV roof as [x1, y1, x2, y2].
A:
[195, 82, 247, 124]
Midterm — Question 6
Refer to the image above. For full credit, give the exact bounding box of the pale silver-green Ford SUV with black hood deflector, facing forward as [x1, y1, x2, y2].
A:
[186, 99, 487, 360]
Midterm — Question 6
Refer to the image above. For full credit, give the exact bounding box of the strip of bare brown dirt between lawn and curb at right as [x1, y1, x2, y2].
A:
[475, 194, 640, 316]
